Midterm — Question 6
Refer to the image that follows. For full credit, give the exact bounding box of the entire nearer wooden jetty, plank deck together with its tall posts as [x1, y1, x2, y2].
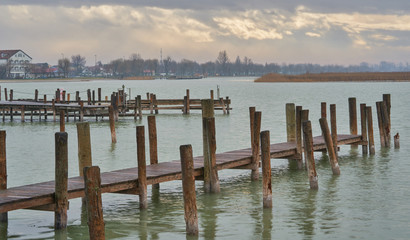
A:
[0, 94, 398, 239]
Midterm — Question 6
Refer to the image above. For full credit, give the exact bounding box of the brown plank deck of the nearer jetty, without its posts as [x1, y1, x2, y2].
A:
[0, 135, 362, 213]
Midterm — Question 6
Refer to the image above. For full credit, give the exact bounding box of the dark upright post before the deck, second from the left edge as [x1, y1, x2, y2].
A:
[54, 132, 68, 229]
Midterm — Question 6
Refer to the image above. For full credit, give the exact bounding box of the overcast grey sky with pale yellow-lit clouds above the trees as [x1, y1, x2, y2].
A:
[0, 0, 410, 65]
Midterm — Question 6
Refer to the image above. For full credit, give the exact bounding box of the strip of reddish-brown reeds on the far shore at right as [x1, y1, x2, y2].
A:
[254, 72, 410, 82]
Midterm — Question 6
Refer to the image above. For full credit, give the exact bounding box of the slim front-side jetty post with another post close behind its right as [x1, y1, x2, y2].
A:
[137, 126, 148, 209]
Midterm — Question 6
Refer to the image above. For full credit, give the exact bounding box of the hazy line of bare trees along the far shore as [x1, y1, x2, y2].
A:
[0, 50, 410, 78]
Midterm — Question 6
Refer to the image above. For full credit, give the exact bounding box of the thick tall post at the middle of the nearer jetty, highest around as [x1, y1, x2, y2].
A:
[201, 99, 220, 193]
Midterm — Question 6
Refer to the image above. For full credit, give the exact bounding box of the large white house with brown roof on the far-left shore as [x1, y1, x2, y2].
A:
[0, 50, 32, 78]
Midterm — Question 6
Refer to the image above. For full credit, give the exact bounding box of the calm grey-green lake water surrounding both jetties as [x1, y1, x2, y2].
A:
[0, 78, 410, 239]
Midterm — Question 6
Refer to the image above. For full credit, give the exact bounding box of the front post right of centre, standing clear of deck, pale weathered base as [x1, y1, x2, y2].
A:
[261, 131, 272, 208]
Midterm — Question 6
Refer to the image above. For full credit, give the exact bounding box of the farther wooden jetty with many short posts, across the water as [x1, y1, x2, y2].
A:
[0, 87, 232, 122]
